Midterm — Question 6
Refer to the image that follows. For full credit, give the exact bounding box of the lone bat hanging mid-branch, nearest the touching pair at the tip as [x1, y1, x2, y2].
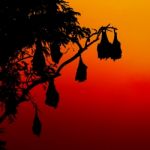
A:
[75, 56, 87, 82]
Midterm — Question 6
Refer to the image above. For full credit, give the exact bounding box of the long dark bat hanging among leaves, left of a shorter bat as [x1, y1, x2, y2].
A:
[32, 41, 46, 74]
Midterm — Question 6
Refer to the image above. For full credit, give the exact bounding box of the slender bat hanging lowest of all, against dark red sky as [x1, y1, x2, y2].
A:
[32, 112, 42, 136]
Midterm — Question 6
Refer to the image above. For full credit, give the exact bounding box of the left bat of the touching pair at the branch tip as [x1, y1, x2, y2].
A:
[97, 30, 111, 59]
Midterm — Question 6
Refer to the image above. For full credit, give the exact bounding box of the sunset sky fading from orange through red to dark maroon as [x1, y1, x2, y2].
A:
[2, 0, 150, 150]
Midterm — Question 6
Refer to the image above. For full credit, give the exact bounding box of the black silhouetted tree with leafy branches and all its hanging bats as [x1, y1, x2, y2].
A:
[0, 0, 121, 138]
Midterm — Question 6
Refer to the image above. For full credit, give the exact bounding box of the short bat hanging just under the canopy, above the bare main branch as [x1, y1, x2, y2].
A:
[50, 42, 63, 64]
